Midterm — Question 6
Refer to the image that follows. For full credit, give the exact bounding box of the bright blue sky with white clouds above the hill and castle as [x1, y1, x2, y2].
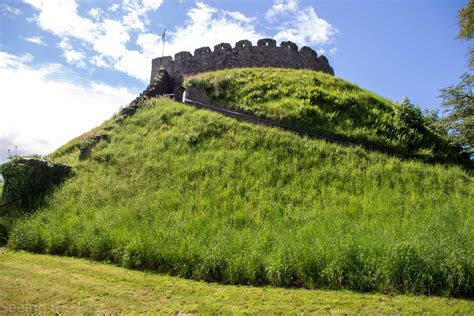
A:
[0, 0, 468, 162]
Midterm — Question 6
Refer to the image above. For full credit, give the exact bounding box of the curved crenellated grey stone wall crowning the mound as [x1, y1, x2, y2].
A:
[151, 38, 334, 80]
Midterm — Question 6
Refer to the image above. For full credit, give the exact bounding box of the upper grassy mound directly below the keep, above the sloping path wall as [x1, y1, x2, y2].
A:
[185, 68, 469, 164]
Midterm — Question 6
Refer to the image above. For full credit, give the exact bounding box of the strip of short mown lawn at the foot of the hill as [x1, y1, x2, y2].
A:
[0, 249, 474, 315]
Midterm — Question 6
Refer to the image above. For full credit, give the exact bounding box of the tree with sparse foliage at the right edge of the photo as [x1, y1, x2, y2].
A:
[440, 0, 474, 155]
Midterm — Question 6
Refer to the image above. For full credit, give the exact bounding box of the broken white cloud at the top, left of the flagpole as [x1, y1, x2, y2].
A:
[25, 0, 162, 82]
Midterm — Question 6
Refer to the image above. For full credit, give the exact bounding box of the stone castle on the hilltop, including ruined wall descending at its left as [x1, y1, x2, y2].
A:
[122, 38, 334, 116]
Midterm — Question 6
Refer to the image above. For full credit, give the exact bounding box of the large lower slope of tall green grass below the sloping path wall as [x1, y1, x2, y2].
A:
[8, 99, 474, 295]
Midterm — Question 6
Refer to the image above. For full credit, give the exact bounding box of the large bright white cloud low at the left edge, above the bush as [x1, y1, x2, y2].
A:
[0, 52, 136, 160]
